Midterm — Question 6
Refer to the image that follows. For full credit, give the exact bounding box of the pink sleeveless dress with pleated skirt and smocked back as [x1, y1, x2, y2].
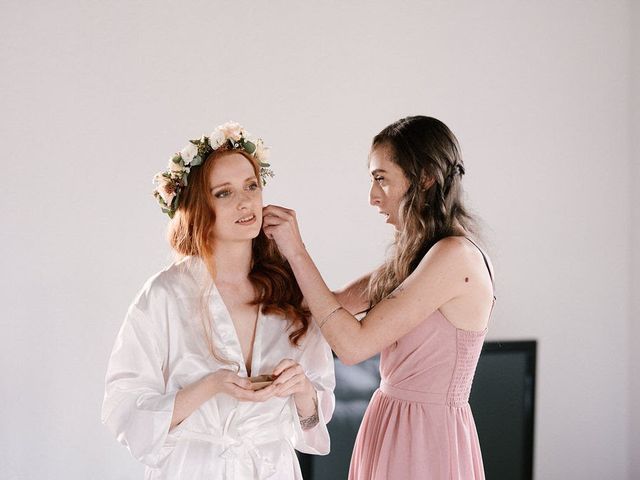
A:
[349, 311, 486, 480]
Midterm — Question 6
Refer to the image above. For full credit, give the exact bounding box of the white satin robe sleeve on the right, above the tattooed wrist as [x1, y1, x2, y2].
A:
[290, 322, 336, 455]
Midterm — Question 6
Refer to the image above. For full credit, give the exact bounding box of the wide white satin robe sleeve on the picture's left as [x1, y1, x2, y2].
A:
[102, 304, 177, 467]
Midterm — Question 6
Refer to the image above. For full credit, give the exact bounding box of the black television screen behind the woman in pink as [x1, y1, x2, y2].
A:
[299, 341, 536, 480]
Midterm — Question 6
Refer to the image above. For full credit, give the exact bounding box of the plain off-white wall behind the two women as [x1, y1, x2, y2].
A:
[0, 0, 640, 480]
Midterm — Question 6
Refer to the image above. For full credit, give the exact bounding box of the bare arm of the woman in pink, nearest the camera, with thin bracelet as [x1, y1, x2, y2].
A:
[264, 206, 472, 365]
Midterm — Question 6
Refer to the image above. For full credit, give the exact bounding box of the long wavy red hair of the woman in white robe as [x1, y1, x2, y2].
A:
[168, 149, 310, 361]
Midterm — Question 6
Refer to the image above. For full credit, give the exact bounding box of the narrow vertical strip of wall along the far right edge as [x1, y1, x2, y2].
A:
[629, 0, 640, 478]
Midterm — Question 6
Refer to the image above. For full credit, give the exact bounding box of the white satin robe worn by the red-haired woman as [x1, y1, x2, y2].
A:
[102, 257, 335, 480]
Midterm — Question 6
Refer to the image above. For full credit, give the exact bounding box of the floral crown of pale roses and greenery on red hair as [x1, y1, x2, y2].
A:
[153, 122, 273, 218]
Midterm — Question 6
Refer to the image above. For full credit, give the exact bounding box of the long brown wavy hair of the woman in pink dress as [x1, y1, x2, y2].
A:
[367, 116, 477, 306]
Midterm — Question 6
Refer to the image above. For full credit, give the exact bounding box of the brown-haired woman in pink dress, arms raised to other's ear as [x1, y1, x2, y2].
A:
[264, 116, 495, 480]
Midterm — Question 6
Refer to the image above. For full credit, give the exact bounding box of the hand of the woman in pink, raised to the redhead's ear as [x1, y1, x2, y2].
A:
[262, 205, 305, 261]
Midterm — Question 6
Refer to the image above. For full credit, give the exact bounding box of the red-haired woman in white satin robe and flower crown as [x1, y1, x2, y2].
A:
[102, 123, 335, 480]
